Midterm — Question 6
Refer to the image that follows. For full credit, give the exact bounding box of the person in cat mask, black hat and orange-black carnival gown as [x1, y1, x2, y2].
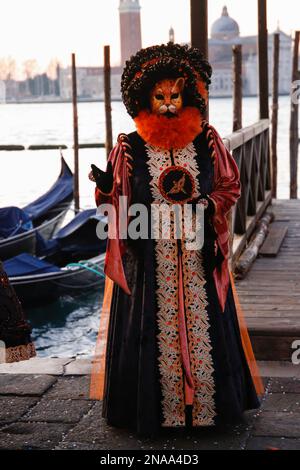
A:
[89, 43, 263, 434]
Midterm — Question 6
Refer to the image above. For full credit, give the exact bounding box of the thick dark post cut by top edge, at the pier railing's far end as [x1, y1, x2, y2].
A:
[257, 0, 269, 119]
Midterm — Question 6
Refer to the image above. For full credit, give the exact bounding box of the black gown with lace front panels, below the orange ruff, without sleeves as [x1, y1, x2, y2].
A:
[92, 123, 259, 434]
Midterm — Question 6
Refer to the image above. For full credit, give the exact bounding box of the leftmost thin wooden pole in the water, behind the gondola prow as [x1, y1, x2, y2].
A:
[72, 53, 80, 212]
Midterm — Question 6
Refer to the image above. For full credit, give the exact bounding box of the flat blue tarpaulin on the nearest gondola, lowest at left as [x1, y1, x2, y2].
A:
[3, 253, 60, 277]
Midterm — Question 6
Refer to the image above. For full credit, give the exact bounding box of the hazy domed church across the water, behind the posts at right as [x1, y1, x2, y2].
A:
[208, 6, 292, 96]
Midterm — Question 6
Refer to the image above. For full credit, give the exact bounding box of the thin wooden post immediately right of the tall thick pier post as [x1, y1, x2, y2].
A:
[271, 33, 280, 198]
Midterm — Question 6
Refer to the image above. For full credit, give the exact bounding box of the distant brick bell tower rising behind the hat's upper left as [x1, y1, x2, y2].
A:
[119, 0, 142, 65]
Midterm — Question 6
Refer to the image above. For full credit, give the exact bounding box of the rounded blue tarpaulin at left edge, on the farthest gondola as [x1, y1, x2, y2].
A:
[0, 206, 33, 239]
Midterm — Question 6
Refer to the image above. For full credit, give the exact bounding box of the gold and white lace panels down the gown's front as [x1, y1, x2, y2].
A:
[146, 143, 216, 427]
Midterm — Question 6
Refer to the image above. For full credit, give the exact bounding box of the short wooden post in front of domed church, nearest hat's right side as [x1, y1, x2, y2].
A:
[232, 44, 243, 132]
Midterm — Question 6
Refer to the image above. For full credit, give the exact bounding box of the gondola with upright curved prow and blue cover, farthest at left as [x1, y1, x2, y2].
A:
[0, 158, 73, 260]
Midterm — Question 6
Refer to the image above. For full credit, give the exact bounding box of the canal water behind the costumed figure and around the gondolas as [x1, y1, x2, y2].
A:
[0, 97, 296, 357]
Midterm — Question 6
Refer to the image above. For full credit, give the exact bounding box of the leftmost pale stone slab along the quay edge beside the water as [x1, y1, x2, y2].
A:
[0, 357, 74, 375]
